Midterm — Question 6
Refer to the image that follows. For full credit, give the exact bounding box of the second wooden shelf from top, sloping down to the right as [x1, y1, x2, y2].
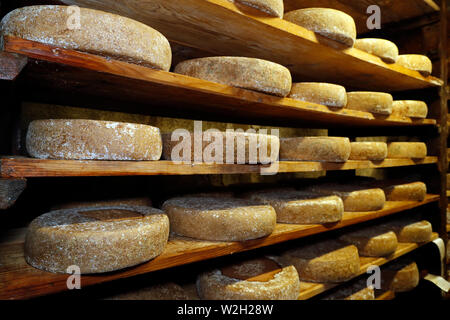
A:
[5, 35, 436, 127]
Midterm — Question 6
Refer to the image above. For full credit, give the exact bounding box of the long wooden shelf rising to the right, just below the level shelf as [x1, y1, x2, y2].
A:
[0, 195, 439, 299]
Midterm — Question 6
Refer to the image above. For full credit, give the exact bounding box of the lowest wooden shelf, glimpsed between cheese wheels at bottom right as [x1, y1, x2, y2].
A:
[299, 233, 439, 300]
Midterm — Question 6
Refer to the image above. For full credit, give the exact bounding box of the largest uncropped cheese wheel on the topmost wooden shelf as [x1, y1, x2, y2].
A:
[284, 8, 356, 47]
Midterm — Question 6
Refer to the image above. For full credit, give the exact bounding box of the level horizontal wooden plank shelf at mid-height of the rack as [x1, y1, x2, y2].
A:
[0, 157, 437, 178]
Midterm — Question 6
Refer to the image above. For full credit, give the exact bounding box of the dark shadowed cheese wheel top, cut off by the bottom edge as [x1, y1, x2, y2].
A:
[105, 282, 191, 300]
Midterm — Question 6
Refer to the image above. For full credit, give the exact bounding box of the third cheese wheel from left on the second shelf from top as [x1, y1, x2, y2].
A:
[289, 82, 347, 108]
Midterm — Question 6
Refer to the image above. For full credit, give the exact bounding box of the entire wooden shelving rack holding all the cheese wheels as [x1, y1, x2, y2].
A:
[0, 0, 448, 300]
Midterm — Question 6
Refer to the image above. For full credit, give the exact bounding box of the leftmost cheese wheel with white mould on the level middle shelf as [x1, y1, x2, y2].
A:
[26, 119, 162, 160]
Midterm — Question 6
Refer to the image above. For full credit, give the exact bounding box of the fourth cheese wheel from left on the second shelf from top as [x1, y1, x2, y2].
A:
[346, 91, 394, 115]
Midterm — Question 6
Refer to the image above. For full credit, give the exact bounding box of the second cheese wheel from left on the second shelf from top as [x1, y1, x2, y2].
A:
[174, 57, 292, 97]
